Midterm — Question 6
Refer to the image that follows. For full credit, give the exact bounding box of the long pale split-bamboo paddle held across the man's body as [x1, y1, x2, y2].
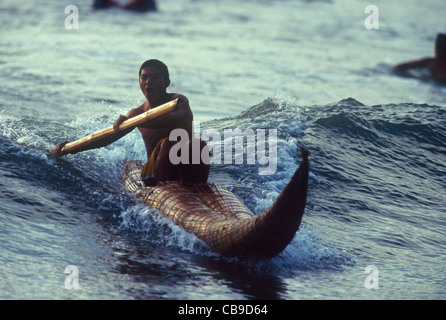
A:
[55, 98, 178, 156]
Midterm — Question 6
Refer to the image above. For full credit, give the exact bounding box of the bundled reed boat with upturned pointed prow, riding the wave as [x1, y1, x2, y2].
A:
[122, 147, 309, 258]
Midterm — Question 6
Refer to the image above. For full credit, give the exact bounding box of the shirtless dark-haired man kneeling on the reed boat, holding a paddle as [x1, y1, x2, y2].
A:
[53, 59, 209, 186]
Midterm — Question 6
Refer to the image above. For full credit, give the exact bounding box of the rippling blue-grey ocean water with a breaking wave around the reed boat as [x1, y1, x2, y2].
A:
[0, 0, 446, 300]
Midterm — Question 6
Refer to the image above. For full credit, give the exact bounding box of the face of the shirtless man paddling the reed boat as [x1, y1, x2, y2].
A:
[139, 67, 170, 102]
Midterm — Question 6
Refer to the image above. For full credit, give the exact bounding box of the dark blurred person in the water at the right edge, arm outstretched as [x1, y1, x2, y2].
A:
[394, 33, 446, 82]
